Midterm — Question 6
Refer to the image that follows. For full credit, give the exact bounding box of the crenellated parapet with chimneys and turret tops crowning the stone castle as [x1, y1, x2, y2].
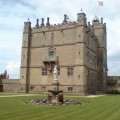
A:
[24, 13, 106, 32]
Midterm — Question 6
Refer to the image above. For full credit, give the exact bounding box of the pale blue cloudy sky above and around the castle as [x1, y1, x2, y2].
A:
[0, 0, 120, 79]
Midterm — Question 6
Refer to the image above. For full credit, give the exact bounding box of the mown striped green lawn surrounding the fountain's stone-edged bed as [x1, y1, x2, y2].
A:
[0, 94, 120, 120]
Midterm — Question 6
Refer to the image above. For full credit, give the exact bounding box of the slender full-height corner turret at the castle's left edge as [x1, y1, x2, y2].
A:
[21, 19, 31, 93]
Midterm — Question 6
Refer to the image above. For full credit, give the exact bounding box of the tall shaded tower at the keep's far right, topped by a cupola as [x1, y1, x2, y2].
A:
[92, 16, 107, 91]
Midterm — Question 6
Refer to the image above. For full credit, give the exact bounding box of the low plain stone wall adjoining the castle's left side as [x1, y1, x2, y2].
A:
[2, 79, 20, 92]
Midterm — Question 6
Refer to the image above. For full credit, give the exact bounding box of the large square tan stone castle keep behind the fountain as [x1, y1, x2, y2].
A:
[20, 13, 107, 94]
